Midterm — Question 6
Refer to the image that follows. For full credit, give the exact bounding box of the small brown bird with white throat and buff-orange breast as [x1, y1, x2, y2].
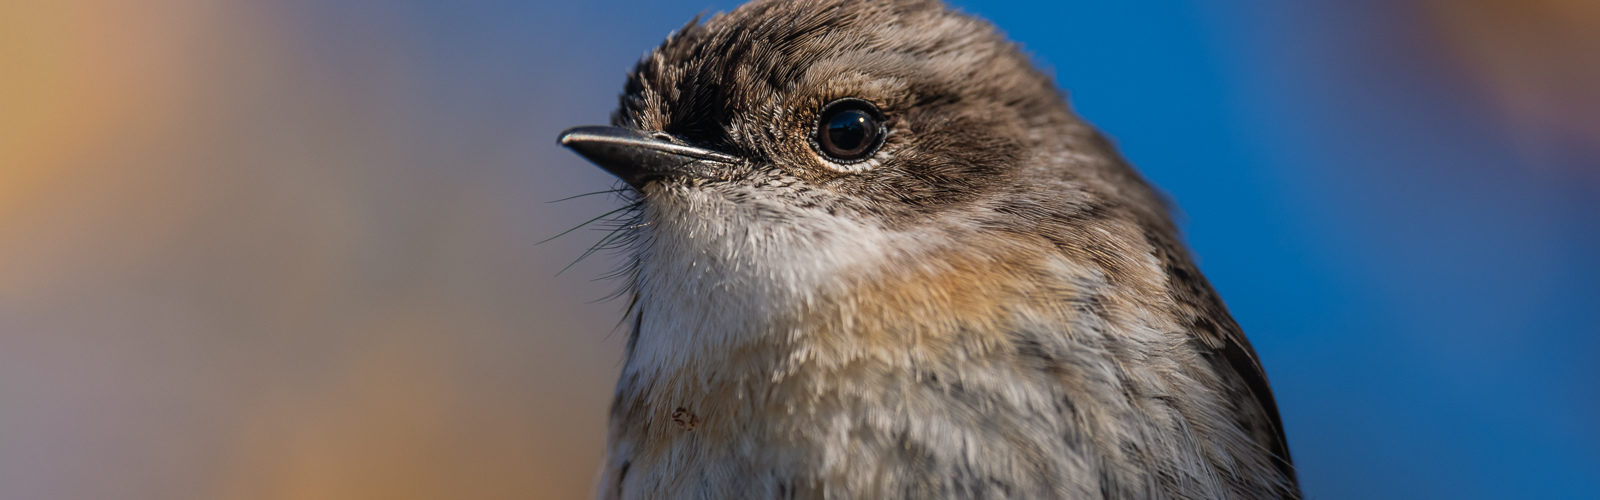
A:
[560, 0, 1299, 498]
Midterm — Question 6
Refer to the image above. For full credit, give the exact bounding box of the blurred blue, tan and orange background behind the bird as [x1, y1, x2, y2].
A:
[0, 0, 1600, 500]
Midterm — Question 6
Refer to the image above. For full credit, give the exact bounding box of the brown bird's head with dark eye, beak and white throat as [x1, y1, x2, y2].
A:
[560, 0, 1166, 371]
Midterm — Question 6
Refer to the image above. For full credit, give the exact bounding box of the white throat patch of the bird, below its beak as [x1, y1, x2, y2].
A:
[622, 189, 917, 383]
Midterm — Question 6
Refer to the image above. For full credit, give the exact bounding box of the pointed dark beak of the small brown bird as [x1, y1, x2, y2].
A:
[560, 127, 736, 189]
